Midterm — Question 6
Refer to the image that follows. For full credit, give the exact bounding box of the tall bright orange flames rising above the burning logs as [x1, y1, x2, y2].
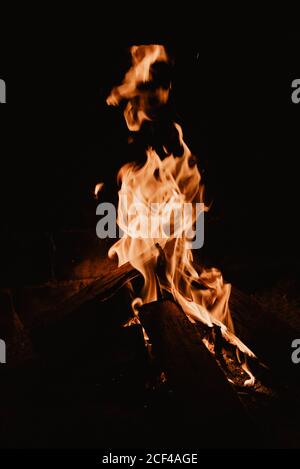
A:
[107, 45, 254, 384]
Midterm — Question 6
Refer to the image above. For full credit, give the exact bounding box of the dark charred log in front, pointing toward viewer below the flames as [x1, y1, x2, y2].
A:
[139, 300, 258, 448]
